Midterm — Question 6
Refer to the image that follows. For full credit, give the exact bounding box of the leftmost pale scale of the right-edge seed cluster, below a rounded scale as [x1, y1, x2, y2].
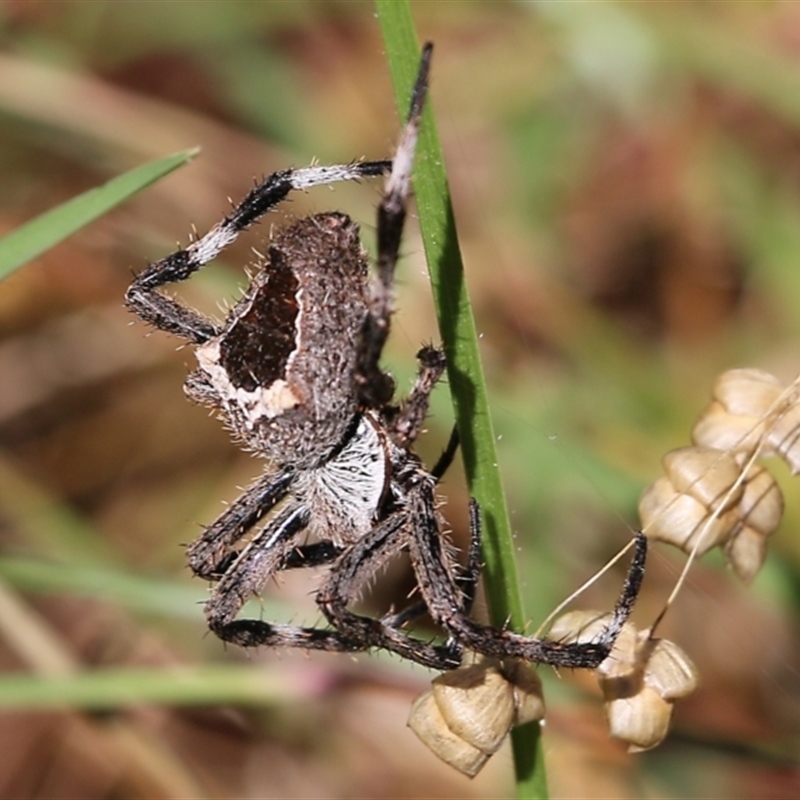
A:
[639, 478, 738, 555]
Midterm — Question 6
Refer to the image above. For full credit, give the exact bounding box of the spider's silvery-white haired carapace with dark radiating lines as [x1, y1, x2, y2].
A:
[298, 413, 390, 546]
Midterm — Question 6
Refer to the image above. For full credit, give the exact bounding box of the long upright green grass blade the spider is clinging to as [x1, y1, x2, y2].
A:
[376, 0, 548, 798]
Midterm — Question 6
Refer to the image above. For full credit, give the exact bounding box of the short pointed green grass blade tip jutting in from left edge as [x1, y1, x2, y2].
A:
[0, 148, 198, 280]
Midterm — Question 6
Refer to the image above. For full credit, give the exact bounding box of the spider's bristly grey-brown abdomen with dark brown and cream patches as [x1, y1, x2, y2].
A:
[194, 212, 369, 467]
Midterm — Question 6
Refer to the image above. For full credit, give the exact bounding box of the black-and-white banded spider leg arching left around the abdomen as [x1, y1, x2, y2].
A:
[125, 161, 390, 344]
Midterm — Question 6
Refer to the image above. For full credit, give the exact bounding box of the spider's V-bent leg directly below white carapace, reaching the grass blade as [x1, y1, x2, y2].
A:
[317, 511, 461, 670]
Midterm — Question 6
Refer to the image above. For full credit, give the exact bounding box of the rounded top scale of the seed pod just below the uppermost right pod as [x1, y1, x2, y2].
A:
[662, 447, 742, 511]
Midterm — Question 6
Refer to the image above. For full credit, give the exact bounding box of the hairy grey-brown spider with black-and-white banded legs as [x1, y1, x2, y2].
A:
[126, 44, 646, 669]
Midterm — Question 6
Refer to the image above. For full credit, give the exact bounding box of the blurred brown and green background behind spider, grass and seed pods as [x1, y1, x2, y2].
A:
[0, 0, 800, 798]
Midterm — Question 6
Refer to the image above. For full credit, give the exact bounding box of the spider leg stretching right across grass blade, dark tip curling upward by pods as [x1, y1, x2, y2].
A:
[409, 481, 647, 669]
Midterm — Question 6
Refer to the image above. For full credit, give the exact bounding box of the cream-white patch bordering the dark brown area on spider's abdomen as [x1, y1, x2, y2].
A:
[195, 338, 300, 430]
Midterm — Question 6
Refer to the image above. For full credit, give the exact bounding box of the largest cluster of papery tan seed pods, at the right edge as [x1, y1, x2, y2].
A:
[639, 369, 800, 583]
